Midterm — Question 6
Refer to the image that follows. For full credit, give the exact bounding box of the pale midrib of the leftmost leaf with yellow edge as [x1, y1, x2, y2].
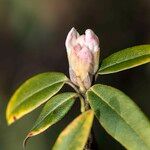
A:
[9, 80, 65, 114]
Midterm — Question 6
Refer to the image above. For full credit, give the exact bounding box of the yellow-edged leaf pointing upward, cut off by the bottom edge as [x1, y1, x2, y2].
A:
[53, 110, 94, 150]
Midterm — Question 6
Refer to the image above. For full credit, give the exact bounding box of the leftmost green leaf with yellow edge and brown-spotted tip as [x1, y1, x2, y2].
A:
[6, 72, 68, 124]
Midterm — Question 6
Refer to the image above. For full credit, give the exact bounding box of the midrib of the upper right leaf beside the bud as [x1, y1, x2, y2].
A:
[100, 54, 150, 72]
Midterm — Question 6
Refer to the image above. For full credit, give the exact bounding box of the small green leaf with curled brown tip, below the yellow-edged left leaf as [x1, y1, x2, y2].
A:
[27, 92, 77, 138]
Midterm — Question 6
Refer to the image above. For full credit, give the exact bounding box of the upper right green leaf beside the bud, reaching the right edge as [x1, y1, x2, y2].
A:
[98, 45, 150, 74]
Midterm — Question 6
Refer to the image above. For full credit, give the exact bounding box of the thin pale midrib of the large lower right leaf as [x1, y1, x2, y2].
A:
[91, 88, 149, 149]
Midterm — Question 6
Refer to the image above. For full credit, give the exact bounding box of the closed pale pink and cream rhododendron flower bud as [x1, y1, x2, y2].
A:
[66, 28, 100, 92]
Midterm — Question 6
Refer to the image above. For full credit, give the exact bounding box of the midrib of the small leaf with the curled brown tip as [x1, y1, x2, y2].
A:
[31, 95, 75, 129]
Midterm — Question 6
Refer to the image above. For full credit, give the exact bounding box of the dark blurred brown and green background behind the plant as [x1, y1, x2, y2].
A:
[0, 0, 150, 150]
